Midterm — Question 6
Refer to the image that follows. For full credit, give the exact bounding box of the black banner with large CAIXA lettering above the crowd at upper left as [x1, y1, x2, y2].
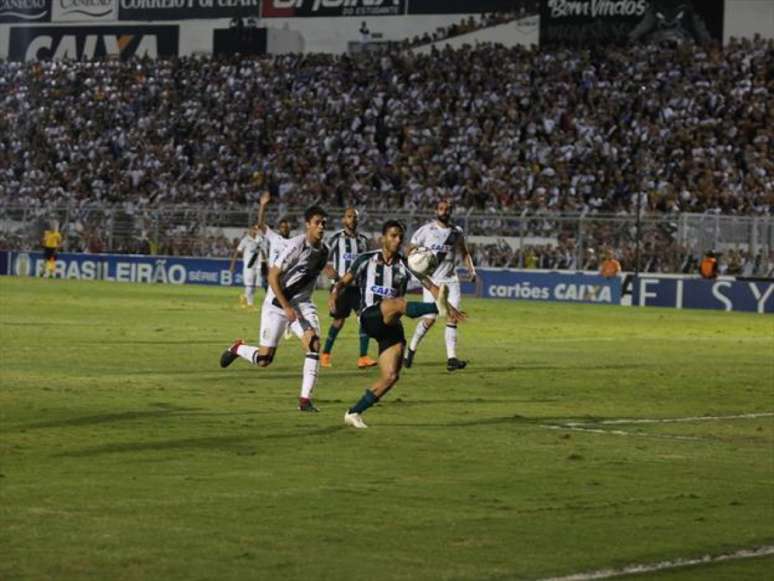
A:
[8, 25, 179, 61]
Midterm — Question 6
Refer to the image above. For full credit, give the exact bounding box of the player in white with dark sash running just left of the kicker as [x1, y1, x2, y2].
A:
[220, 206, 328, 412]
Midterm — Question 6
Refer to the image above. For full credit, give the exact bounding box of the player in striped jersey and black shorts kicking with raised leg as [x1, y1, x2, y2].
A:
[328, 220, 465, 429]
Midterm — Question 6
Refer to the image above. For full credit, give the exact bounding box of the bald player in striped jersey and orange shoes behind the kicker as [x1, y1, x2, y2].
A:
[320, 208, 378, 369]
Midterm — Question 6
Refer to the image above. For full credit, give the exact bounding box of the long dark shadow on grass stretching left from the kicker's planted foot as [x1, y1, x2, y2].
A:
[52, 426, 345, 458]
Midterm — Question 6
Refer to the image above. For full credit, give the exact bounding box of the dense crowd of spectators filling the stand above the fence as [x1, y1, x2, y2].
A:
[0, 34, 774, 274]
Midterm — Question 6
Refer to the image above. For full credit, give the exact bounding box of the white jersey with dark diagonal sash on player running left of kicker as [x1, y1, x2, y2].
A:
[265, 234, 328, 307]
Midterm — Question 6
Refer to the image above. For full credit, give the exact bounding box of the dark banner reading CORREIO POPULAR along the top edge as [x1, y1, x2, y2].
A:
[118, 0, 260, 21]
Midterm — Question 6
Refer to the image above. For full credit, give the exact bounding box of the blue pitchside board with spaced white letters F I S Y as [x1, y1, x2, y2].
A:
[632, 276, 774, 313]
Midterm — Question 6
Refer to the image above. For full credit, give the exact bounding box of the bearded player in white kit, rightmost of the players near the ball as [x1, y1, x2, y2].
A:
[404, 200, 476, 371]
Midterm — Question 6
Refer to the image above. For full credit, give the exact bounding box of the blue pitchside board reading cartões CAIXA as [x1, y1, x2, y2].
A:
[478, 269, 621, 305]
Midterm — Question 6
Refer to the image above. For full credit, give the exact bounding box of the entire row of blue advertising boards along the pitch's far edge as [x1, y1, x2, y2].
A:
[0, 252, 774, 313]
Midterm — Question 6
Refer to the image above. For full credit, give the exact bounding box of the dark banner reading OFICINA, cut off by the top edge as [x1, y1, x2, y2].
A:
[261, 0, 406, 18]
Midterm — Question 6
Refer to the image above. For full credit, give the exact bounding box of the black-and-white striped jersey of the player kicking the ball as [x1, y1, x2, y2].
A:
[349, 250, 412, 311]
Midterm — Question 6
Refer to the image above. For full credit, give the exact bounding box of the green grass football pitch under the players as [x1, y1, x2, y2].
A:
[0, 277, 774, 581]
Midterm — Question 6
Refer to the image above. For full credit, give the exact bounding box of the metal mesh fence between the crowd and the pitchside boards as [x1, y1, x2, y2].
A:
[0, 206, 774, 276]
